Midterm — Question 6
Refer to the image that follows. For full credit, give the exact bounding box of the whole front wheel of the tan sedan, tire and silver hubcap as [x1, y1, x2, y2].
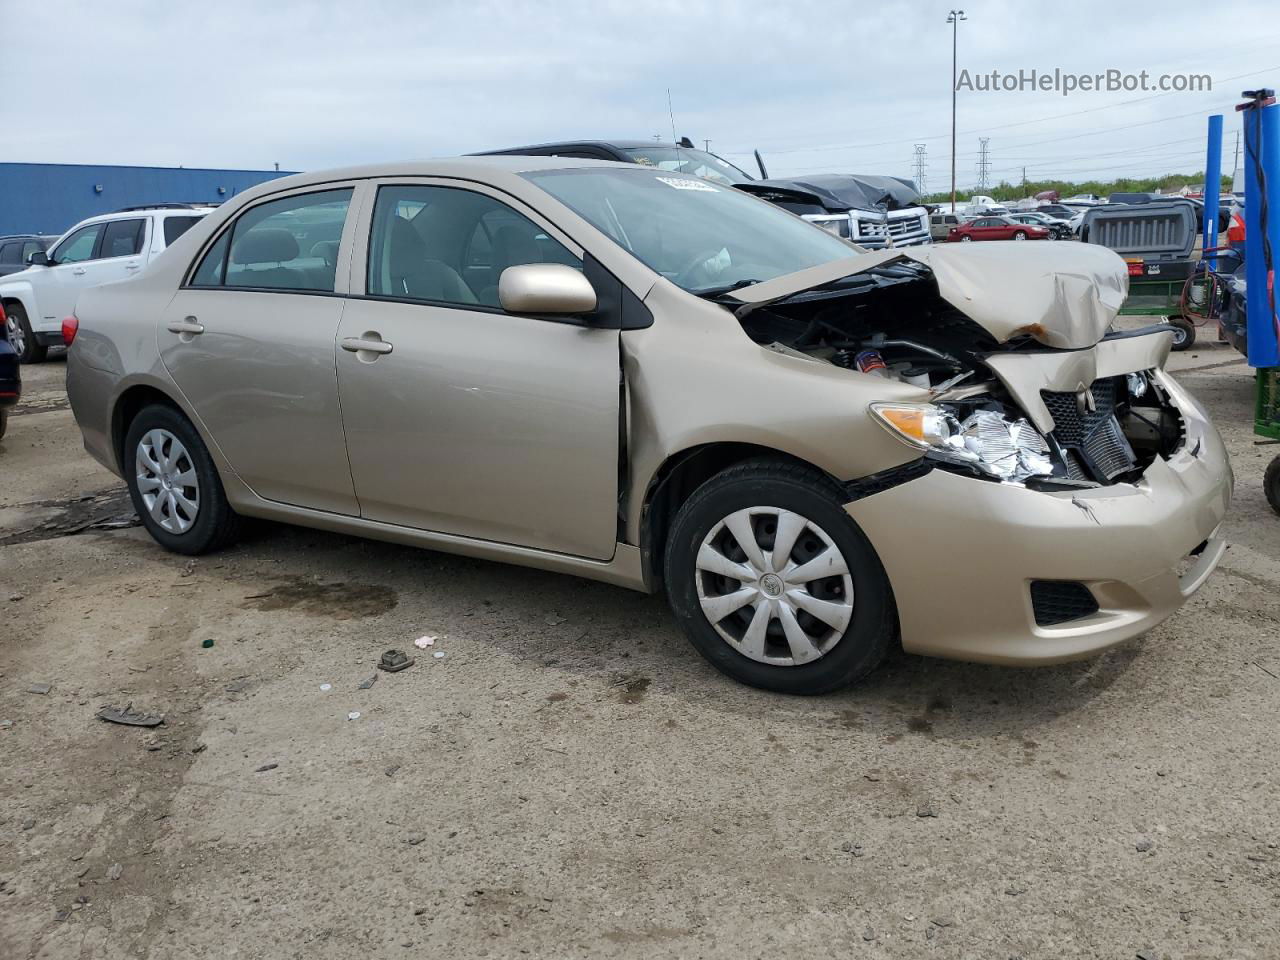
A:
[666, 461, 893, 695]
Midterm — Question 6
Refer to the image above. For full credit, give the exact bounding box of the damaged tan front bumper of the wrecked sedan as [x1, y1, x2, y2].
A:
[845, 374, 1233, 664]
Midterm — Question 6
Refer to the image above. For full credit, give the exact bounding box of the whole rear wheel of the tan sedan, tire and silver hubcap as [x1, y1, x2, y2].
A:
[122, 404, 243, 554]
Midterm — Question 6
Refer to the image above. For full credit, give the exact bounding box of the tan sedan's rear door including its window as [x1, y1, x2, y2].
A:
[159, 184, 358, 516]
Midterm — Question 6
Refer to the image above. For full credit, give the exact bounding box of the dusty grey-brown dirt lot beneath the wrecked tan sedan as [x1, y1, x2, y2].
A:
[0, 344, 1280, 960]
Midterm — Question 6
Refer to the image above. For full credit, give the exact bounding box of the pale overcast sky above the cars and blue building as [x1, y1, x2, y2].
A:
[10, 0, 1280, 191]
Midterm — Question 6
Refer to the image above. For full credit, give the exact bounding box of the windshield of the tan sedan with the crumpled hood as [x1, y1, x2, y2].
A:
[524, 166, 860, 296]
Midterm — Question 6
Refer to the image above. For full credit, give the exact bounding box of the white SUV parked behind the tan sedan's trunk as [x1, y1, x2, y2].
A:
[0, 204, 212, 364]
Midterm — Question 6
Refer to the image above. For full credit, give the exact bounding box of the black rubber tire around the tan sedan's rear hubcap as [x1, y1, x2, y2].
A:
[120, 403, 244, 556]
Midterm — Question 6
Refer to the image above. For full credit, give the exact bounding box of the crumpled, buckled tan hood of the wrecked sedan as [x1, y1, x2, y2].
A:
[730, 241, 1129, 349]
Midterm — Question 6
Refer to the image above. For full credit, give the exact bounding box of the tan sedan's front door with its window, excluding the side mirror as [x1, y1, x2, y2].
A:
[338, 182, 621, 559]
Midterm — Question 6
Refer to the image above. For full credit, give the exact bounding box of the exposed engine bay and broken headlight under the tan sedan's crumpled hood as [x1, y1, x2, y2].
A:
[724, 261, 1184, 489]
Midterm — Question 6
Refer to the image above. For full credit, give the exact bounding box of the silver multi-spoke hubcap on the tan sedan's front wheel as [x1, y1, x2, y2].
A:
[695, 507, 854, 667]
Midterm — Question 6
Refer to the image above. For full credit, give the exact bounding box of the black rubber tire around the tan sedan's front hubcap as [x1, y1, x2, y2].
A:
[664, 460, 896, 695]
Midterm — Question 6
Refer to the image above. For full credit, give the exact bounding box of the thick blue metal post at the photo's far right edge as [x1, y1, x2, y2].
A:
[1243, 106, 1280, 367]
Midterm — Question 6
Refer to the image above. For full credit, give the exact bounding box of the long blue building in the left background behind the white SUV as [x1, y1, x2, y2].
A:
[0, 163, 291, 237]
